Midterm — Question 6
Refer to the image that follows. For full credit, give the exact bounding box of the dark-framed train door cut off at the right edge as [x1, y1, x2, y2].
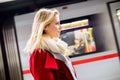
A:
[108, 1, 120, 53]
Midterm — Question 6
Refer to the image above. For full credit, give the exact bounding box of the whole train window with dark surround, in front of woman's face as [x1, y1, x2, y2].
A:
[60, 14, 104, 57]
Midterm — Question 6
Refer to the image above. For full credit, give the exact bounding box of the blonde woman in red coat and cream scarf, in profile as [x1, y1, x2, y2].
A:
[25, 8, 77, 80]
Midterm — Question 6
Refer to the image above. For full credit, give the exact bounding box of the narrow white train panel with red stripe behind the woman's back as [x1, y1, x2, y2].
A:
[14, 12, 35, 80]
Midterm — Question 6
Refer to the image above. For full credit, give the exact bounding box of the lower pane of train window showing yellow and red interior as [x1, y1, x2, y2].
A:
[61, 28, 96, 55]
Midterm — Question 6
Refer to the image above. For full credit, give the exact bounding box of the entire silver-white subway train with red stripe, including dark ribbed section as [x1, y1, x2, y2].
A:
[0, 0, 120, 80]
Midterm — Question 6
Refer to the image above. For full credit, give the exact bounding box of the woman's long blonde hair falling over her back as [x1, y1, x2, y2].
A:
[24, 8, 59, 52]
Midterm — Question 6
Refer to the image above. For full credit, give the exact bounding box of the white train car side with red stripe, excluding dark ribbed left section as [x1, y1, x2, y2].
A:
[15, 0, 120, 80]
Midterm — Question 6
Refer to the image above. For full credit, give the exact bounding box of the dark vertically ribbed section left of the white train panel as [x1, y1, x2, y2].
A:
[0, 15, 22, 80]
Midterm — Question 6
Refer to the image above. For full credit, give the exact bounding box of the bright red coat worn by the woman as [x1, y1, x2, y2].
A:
[30, 50, 74, 80]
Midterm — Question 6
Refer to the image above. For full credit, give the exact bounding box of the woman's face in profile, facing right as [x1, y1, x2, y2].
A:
[45, 15, 61, 38]
